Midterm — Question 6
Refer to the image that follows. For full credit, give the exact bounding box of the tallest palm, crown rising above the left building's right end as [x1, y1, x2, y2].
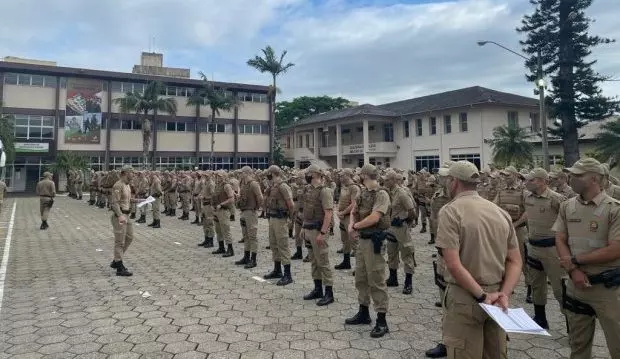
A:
[247, 45, 295, 163]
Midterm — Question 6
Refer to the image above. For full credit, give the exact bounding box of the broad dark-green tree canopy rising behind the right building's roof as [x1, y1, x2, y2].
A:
[275, 96, 349, 128]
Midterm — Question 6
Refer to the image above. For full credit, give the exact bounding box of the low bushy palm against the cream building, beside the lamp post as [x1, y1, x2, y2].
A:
[489, 124, 533, 166]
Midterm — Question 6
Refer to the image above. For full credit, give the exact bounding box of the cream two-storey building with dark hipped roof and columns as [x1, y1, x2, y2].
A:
[279, 86, 540, 170]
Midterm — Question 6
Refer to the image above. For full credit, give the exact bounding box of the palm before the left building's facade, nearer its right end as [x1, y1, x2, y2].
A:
[187, 72, 239, 169]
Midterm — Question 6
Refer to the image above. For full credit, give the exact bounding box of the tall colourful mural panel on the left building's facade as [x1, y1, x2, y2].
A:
[65, 79, 103, 144]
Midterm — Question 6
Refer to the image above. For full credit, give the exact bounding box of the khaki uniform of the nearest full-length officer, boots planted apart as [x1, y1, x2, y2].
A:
[354, 187, 390, 313]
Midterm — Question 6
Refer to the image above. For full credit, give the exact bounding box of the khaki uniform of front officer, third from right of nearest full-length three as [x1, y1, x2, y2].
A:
[265, 182, 293, 265]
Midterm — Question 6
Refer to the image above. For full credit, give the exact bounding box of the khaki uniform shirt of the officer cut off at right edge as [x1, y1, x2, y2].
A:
[552, 192, 620, 275]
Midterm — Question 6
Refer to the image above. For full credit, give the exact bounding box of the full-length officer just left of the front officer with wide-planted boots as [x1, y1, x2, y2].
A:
[302, 165, 334, 306]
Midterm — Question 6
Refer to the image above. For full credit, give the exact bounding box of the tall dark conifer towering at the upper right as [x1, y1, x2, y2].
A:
[517, 0, 618, 166]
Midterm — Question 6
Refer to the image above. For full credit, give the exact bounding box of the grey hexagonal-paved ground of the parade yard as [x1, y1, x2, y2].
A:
[0, 197, 608, 359]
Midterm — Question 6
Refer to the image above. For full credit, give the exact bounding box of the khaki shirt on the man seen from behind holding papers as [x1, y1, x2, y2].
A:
[436, 191, 518, 285]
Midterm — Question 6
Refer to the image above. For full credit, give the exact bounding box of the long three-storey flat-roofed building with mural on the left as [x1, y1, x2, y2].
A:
[0, 53, 270, 191]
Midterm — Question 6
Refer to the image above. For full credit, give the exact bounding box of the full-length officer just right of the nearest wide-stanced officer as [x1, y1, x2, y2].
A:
[384, 169, 416, 294]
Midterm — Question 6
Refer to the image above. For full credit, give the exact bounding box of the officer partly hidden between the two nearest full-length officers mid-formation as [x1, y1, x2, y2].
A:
[334, 168, 361, 270]
